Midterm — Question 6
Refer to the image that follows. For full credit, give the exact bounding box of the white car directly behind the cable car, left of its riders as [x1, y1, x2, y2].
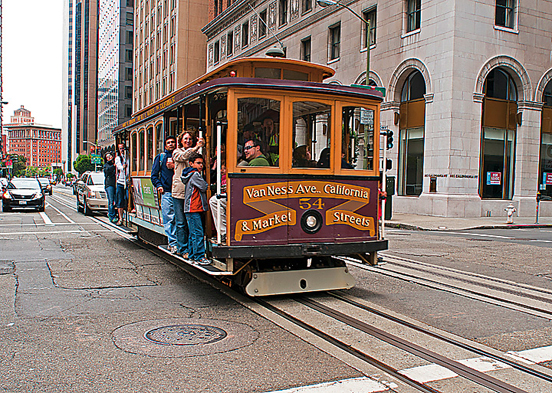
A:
[75, 172, 107, 215]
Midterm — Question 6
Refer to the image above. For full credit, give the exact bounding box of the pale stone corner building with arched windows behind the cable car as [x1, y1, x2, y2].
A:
[203, 0, 552, 217]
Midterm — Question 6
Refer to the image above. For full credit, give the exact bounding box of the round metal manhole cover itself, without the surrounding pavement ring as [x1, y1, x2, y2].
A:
[146, 325, 226, 345]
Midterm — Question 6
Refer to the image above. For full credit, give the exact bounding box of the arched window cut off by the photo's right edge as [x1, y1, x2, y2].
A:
[538, 81, 552, 197]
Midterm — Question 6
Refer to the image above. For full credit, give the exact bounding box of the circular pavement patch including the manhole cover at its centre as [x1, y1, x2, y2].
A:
[112, 318, 259, 357]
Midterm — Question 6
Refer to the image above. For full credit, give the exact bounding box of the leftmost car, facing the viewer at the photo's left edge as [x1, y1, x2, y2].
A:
[2, 178, 46, 212]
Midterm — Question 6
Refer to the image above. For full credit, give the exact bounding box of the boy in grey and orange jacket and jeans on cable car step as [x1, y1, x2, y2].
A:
[181, 152, 211, 265]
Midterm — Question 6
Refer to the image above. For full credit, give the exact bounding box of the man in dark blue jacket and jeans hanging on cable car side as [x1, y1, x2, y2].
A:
[151, 136, 177, 254]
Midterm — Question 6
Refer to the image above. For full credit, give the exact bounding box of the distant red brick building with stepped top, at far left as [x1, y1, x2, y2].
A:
[4, 106, 61, 168]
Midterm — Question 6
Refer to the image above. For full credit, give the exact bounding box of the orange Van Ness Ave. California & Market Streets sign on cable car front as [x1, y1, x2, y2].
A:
[234, 181, 376, 241]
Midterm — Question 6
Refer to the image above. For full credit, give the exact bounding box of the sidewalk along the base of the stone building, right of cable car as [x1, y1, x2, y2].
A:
[385, 213, 552, 231]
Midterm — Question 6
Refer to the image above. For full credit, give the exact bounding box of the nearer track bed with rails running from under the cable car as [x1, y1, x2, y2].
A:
[256, 293, 552, 393]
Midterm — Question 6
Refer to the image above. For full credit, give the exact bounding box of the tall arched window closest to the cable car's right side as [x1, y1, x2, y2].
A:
[397, 71, 426, 195]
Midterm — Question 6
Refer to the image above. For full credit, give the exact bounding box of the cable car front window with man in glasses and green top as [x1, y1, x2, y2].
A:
[238, 98, 280, 166]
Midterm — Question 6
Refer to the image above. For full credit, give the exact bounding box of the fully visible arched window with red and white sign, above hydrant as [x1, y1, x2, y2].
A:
[479, 68, 517, 199]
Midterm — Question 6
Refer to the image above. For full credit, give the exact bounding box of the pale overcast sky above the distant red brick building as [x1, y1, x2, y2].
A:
[2, 0, 63, 128]
